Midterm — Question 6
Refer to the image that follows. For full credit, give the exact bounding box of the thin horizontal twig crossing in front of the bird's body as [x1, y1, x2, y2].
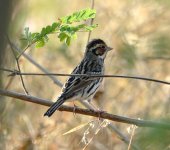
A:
[0, 68, 170, 85]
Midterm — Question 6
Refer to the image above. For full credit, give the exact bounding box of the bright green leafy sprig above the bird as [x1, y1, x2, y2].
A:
[22, 8, 97, 48]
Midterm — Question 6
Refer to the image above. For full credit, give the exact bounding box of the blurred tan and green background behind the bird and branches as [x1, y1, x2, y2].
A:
[0, 0, 170, 150]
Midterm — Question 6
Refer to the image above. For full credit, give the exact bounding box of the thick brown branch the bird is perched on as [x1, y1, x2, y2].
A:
[0, 90, 170, 130]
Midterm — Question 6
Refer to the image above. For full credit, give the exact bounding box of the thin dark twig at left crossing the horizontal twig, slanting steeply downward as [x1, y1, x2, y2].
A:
[7, 36, 28, 94]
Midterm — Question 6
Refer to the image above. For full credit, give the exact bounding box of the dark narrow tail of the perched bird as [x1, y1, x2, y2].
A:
[44, 99, 65, 117]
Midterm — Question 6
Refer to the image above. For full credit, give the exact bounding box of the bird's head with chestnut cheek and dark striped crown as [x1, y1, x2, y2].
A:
[86, 39, 112, 59]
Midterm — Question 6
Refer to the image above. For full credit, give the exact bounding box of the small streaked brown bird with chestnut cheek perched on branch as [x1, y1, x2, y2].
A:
[44, 39, 112, 117]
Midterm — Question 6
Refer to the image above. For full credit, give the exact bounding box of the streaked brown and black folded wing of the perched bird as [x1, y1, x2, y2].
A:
[60, 59, 103, 99]
